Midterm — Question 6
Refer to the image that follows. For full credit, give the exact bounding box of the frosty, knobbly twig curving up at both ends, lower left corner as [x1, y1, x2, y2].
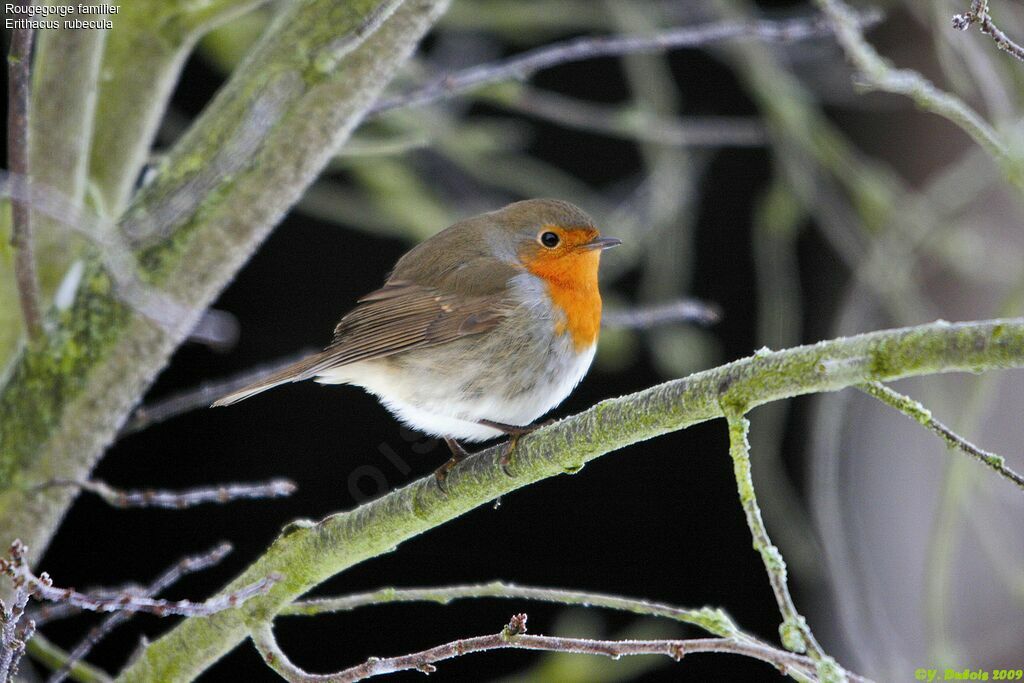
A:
[0, 541, 282, 616]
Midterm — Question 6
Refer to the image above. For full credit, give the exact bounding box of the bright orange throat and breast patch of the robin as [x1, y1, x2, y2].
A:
[526, 251, 601, 351]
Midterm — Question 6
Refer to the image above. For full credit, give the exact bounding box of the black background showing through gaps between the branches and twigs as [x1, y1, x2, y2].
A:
[4, 3, 888, 681]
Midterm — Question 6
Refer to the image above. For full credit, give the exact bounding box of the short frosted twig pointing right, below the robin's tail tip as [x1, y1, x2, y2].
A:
[39, 479, 296, 510]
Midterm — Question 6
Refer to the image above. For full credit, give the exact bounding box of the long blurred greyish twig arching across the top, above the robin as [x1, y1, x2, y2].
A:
[368, 13, 879, 116]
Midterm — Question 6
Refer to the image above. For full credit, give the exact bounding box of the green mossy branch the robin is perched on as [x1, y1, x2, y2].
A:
[120, 318, 1024, 681]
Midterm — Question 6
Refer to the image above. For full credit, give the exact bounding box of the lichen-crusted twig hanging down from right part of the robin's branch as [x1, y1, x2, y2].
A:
[723, 405, 842, 672]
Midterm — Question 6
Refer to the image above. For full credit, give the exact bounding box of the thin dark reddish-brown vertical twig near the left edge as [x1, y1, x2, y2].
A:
[7, 0, 43, 340]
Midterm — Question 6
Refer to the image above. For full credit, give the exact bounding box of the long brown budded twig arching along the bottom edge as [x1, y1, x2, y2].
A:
[252, 614, 843, 683]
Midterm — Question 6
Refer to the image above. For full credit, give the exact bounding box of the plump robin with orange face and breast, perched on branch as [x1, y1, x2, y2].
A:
[214, 200, 621, 478]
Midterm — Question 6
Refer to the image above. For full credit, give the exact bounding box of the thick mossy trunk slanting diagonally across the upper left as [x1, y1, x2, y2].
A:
[0, 0, 446, 581]
